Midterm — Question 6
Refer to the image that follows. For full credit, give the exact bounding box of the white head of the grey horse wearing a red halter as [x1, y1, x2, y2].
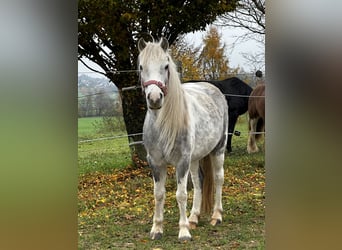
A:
[138, 38, 170, 110]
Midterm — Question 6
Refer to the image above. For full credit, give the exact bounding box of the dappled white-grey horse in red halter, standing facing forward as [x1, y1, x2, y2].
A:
[138, 38, 228, 241]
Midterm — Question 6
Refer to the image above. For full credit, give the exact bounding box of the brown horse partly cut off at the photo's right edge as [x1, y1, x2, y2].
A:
[247, 84, 265, 153]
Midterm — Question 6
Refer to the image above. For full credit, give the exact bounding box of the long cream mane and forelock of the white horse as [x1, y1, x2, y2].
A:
[139, 43, 189, 156]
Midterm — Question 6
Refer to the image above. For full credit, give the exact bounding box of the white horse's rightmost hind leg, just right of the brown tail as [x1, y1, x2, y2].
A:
[210, 153, 224, 226]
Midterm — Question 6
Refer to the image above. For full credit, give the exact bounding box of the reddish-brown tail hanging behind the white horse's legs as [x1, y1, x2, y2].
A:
[200, 155, 214, 213]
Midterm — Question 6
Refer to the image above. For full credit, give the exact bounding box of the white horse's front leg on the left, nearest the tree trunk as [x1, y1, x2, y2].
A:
[149, 160, 166, 240]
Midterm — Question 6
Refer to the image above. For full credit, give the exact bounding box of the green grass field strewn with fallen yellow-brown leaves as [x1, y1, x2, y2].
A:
[78, 116, 265, 249]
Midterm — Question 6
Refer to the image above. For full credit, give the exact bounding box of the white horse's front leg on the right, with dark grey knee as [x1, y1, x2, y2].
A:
[176, 157, 191, 241]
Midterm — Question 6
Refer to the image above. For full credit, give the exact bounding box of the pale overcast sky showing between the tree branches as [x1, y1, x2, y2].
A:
[78, 27, 264, 77]
